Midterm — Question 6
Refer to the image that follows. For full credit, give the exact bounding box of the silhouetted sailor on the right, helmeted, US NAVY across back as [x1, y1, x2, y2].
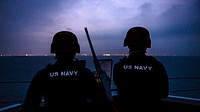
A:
[113, 27, 169, 112]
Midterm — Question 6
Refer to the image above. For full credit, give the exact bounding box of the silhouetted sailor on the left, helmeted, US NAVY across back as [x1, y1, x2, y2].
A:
[21, 31, 98, 112]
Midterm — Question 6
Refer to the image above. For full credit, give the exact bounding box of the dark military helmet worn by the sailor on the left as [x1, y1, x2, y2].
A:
[51, 31, 80, 53]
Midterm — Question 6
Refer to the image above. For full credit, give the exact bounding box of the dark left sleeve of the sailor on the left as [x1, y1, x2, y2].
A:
[22, 72, 42, 112]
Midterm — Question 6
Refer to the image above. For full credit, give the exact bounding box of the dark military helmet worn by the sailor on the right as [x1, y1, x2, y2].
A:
[124, 27, 151, 48]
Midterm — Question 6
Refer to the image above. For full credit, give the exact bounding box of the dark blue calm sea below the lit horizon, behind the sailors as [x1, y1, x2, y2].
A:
[0, 56, 200, 103]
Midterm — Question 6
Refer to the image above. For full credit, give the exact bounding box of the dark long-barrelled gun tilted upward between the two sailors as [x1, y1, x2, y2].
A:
[84, 27, 113, 103]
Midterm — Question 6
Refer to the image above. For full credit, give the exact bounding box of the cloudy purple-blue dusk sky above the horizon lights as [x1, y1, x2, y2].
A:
[0, 0, 200, 56]
